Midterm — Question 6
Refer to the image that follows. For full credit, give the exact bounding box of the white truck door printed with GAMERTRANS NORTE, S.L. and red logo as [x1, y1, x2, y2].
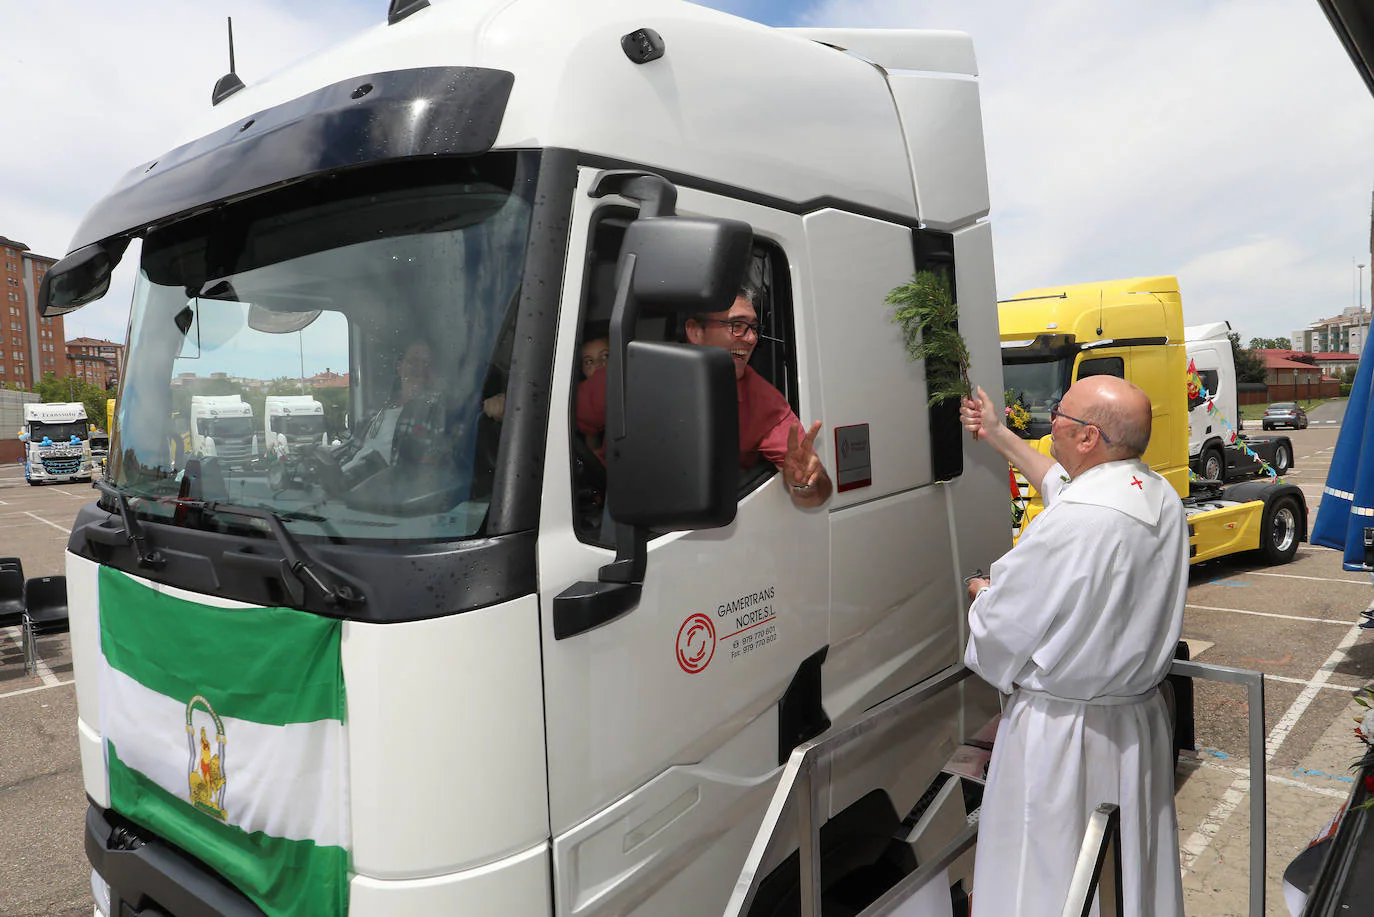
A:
[533, 169, 834, 914]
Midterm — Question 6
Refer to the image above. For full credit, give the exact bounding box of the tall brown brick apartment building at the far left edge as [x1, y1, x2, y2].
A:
[0, 235, 67, 389]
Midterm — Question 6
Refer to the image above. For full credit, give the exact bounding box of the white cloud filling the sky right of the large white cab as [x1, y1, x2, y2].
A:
[802, 0, 1374, 340]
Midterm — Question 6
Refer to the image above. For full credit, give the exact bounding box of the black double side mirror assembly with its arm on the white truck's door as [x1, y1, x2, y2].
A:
[554, 204, 753, 639]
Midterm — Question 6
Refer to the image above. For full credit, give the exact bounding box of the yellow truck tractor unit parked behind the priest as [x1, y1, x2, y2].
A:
[998, 276, 1308, 564]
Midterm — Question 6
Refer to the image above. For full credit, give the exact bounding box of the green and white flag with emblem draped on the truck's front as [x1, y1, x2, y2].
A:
[100, 566, 349, 914]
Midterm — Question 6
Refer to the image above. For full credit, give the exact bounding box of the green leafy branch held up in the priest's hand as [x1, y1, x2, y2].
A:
[886, 271, 973, 407]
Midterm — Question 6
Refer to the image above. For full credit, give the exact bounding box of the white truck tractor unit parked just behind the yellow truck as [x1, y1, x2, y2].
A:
[1183, 322, 1293, 483]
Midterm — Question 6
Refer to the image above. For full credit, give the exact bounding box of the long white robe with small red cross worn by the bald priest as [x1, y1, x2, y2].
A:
[965, 461, 1189, 917]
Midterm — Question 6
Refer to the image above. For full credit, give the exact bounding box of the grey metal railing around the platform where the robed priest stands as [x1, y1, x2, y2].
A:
[725, 660, 1265, 917]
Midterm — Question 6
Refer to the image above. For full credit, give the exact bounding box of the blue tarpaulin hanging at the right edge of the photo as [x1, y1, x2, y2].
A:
[1312, 348, 1374, 571]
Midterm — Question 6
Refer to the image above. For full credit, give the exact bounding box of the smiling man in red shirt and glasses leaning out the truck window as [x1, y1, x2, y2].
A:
[577, 283, 833, 506]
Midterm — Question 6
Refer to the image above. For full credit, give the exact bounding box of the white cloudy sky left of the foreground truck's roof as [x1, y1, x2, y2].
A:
[0, 0, 386, 340]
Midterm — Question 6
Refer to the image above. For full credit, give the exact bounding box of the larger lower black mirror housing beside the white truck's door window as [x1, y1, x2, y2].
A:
[606, 341, 739, 531]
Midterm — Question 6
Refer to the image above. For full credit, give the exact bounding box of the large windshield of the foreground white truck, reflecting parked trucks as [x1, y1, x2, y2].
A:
[109, 153, 539, 542]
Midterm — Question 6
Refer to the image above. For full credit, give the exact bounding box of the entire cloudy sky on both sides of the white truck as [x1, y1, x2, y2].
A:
[0, 0, 1374, 342]
